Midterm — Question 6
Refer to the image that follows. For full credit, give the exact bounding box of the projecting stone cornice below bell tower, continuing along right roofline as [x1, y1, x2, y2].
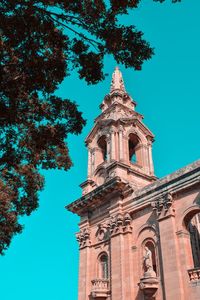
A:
[66, 160, 200, 215]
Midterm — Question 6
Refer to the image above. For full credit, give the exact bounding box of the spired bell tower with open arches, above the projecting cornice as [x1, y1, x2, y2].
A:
[81, 67, 156, 194]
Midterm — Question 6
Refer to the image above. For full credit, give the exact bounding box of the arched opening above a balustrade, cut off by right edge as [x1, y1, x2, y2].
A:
[186, 213, 200, 268]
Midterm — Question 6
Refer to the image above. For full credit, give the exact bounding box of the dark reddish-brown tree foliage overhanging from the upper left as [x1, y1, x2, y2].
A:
[0, 0, 180, 253]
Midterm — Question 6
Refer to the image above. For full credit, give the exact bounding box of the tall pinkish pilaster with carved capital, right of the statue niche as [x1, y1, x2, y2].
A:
[154, 194, 186, 300]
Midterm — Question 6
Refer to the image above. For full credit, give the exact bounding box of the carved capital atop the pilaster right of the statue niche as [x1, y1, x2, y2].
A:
[152, 193, 175, 218]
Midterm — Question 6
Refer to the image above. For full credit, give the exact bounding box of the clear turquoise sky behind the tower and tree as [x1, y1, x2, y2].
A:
[0, 0, 200, 300]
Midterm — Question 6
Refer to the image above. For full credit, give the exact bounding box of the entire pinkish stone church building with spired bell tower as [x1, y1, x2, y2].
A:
[67, 68, 200, 300]
